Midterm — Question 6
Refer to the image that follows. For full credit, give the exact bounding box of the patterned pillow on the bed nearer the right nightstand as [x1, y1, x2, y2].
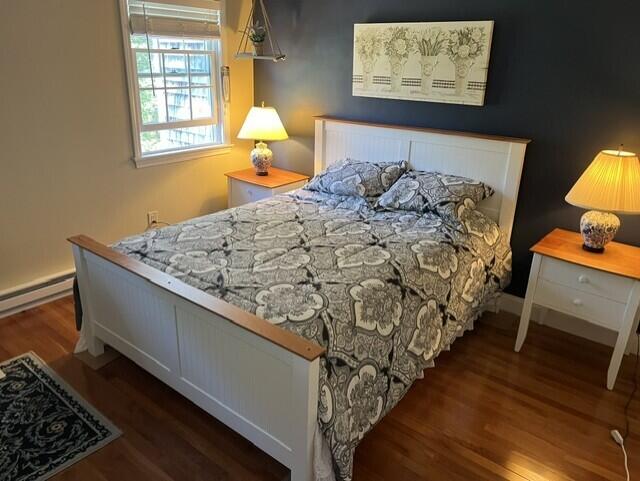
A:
[376, 170, 493, 220]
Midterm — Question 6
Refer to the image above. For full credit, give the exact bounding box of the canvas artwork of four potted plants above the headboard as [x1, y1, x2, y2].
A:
[353, 21, 493, 105]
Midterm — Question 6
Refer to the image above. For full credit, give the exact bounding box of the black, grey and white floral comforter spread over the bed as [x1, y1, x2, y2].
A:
[114, 190, 511, 480]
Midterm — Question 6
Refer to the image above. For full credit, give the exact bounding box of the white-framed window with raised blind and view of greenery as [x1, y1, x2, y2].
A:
[121, 0, 228, 166]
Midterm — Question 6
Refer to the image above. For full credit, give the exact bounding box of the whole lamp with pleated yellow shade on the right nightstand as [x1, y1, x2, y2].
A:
[565, 146, 640, 253]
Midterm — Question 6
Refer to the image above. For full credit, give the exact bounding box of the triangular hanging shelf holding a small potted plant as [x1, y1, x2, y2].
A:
[236, 0, 285, 62]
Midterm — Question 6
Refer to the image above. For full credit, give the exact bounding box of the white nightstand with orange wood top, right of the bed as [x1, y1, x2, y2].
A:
[515, 229, 640, 389]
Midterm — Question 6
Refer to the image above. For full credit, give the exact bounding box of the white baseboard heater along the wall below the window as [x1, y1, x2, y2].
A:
[0, 270, 75, 318]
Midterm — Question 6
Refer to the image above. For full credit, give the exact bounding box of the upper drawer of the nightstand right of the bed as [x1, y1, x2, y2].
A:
[540, 257, 633, 303]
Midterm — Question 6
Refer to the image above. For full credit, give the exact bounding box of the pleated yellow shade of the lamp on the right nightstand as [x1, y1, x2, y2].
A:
[565, 150, 640, 214]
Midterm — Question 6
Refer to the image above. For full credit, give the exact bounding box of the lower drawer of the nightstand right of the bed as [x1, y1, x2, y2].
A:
[534, 278, 628, 330]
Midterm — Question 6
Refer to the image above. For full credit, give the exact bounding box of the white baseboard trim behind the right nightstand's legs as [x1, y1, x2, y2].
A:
[500, 293, 638, 354]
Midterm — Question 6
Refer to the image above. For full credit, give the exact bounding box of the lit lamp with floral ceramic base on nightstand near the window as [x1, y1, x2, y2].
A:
[238, 102, 289, 175]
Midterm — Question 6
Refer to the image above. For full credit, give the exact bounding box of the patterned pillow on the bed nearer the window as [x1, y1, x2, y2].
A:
[305, 159, 407, 197]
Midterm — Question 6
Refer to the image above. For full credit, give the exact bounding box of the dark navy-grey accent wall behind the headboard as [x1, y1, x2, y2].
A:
[255, 0, 640, 295]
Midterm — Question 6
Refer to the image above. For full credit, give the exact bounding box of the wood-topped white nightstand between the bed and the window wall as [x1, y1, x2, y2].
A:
[225, 167, 309, 208]
